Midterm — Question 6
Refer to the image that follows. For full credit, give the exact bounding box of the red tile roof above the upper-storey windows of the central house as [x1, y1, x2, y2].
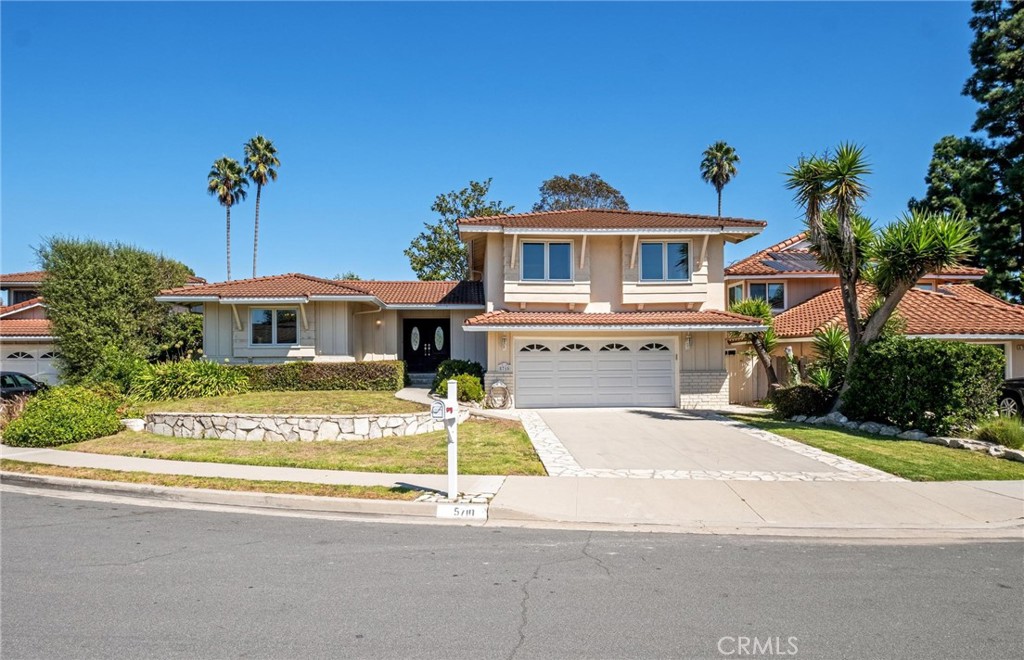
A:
[459, 209, 767, 240]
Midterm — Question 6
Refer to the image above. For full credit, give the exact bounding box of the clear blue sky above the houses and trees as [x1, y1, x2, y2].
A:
[0, 2, 975, 280]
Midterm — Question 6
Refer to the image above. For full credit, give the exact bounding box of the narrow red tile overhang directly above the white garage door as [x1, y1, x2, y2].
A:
[463, 310, 766, 333]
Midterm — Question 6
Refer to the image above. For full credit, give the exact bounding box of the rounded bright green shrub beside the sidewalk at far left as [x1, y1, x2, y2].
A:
[3, 386, 121, 447]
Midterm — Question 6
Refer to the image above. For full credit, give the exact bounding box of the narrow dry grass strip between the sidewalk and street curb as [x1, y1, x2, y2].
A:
[0, 458, 421, 499]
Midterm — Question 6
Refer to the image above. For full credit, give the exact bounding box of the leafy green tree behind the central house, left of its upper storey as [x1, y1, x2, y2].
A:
[406, 179, 513, 280]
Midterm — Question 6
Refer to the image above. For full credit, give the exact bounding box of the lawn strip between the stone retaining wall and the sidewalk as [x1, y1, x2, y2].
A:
[59, 420, 545, 475]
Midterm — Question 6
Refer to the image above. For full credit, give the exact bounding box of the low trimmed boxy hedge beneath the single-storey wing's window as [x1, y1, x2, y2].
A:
[229, 360, 406, 392]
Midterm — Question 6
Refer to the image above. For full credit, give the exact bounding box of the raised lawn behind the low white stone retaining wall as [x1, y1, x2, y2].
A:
[139, 390, 427, 414]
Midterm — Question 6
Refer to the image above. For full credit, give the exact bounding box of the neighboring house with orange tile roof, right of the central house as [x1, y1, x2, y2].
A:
[725, 233, 1024, 403]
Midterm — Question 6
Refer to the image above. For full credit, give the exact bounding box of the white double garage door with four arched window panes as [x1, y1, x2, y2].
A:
[515, 340, 678, 408]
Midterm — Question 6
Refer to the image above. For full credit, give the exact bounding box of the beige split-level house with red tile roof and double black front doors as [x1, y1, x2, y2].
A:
[158, 210, 765, 407]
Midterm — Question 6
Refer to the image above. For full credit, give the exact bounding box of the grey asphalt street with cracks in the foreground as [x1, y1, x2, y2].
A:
[0, 492, 1024, 660]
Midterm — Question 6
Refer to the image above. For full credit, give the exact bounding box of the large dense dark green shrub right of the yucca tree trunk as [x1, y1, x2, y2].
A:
[843, 337, 1005, 435]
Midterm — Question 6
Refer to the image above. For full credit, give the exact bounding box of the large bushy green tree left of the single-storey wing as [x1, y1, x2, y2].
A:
[37, 237, 193, 382]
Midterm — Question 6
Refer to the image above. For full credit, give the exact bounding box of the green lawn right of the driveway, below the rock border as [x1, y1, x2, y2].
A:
[729, 414, 1024, 481]
